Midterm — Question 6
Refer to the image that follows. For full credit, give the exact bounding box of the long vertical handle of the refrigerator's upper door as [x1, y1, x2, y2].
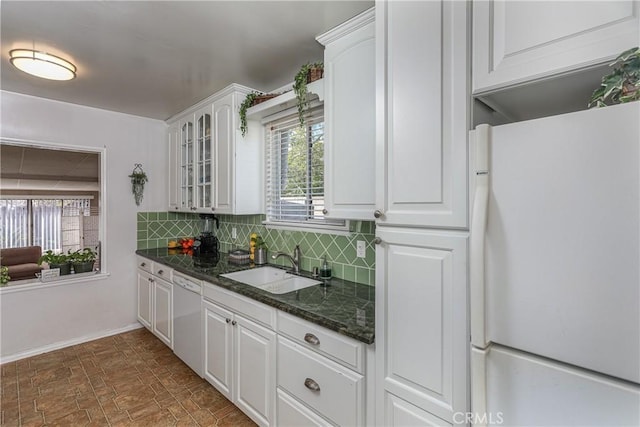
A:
[469, 125, 491, 348]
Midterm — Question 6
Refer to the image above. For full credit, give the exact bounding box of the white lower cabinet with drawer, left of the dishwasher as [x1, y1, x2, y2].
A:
[137, 258, 173, 349]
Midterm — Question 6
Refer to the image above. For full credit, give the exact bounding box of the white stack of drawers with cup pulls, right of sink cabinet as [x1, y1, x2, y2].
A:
[277, 312, 372, 426]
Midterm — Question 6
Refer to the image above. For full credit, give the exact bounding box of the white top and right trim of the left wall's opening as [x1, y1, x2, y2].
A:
[0, 136, 109, 281]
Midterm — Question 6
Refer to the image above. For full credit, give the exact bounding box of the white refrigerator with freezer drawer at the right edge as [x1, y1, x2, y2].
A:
[469, 102, 640, 426]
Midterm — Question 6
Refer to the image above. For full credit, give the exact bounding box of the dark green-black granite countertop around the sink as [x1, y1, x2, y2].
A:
[136, 248, 375, 344]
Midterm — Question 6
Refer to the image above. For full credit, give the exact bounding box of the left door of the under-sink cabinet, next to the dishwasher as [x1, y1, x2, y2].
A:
[203, 301, 233, 400]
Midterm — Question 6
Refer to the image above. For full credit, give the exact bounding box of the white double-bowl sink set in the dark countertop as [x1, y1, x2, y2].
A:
[221, 267, 322, 294]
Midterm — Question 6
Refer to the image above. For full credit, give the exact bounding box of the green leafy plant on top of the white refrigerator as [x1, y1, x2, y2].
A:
[589, 47, 640, 108]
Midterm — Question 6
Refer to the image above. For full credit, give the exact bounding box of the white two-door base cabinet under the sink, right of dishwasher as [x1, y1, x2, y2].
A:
[203, 284, 276, 426]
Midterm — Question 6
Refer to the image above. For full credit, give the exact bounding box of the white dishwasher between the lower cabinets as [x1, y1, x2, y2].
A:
[173, 271, 203, 377]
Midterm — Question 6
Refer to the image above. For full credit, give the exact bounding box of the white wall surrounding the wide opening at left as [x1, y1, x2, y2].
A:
[0, 91, 168, 362]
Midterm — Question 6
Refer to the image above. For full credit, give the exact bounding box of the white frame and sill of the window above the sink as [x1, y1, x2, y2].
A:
[261, 103, 350, 235]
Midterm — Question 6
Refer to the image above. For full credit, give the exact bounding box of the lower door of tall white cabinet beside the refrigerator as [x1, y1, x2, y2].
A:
[376, 227, 468, 420]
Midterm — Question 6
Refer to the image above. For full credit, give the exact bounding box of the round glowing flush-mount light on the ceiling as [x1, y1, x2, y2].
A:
[9, 49, 76, 80]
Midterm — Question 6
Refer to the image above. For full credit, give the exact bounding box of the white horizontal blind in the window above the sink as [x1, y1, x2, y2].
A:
[265, 106, 344, 226]
